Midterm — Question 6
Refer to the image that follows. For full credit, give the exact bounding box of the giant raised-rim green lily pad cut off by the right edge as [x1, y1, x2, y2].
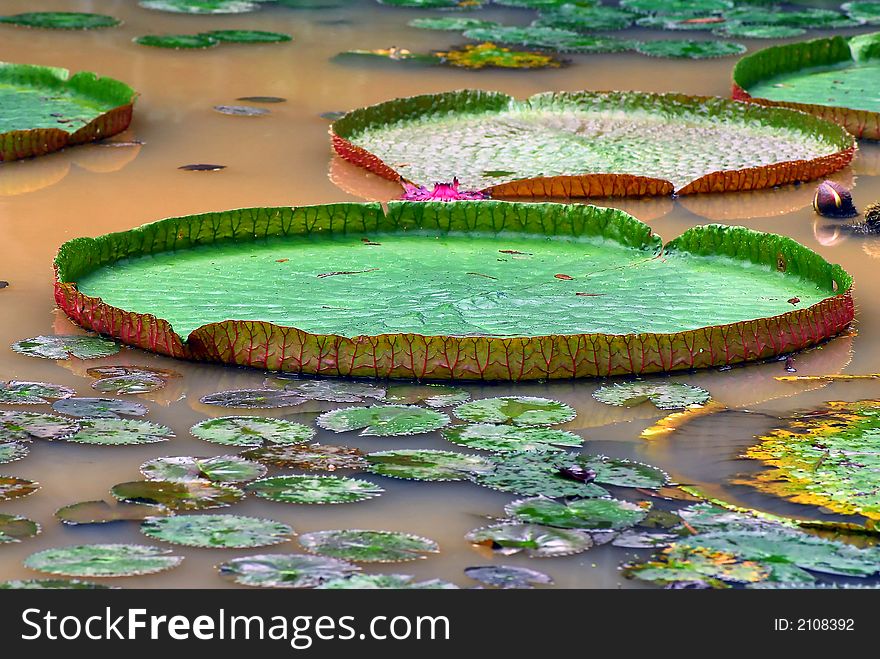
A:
[733, 32, 880, 140]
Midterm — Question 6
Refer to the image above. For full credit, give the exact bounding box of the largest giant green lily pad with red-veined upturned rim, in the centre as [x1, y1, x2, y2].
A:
[56, 201, 854, 378]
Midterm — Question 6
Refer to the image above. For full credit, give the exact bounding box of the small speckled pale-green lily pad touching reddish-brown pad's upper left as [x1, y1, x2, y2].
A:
[190, 416, 315, 448]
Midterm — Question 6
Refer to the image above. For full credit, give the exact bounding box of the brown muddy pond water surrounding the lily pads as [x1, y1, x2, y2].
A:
[0, 0, 880, 587]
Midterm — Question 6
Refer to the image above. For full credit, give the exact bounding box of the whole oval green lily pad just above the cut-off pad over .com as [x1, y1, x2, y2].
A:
[299, 530, 440, 563]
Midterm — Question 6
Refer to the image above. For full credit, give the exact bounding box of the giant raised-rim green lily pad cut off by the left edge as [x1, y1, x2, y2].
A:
[0, 62, 136, 162]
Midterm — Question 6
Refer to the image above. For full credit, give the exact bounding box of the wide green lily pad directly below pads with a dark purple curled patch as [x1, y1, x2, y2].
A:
[504, 497, 647, 531]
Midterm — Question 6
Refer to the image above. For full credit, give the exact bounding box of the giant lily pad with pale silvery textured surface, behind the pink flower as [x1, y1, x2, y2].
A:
[332, 91, 853, 197]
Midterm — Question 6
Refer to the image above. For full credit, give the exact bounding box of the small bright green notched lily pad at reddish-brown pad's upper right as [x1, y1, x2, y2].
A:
[315, 405, 449, 437]
